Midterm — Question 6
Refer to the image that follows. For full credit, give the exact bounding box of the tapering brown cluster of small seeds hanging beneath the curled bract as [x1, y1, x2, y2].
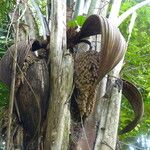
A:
[74, 50, 99, 117]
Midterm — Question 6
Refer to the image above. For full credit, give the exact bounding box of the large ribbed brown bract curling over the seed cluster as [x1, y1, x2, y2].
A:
[75, 15, 126, 83]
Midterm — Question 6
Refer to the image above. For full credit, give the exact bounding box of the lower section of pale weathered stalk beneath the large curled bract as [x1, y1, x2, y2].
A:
[95, 61, 122, 150]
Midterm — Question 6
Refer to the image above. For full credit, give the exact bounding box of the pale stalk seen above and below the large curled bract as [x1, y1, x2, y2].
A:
[94, 0, 121, 150]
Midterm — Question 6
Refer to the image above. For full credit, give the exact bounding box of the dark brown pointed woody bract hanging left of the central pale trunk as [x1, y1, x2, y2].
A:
[0, 40, 49, 149]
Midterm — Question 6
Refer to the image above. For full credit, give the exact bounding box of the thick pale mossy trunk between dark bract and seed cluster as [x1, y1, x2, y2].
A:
[44, 0, 73, 150]
